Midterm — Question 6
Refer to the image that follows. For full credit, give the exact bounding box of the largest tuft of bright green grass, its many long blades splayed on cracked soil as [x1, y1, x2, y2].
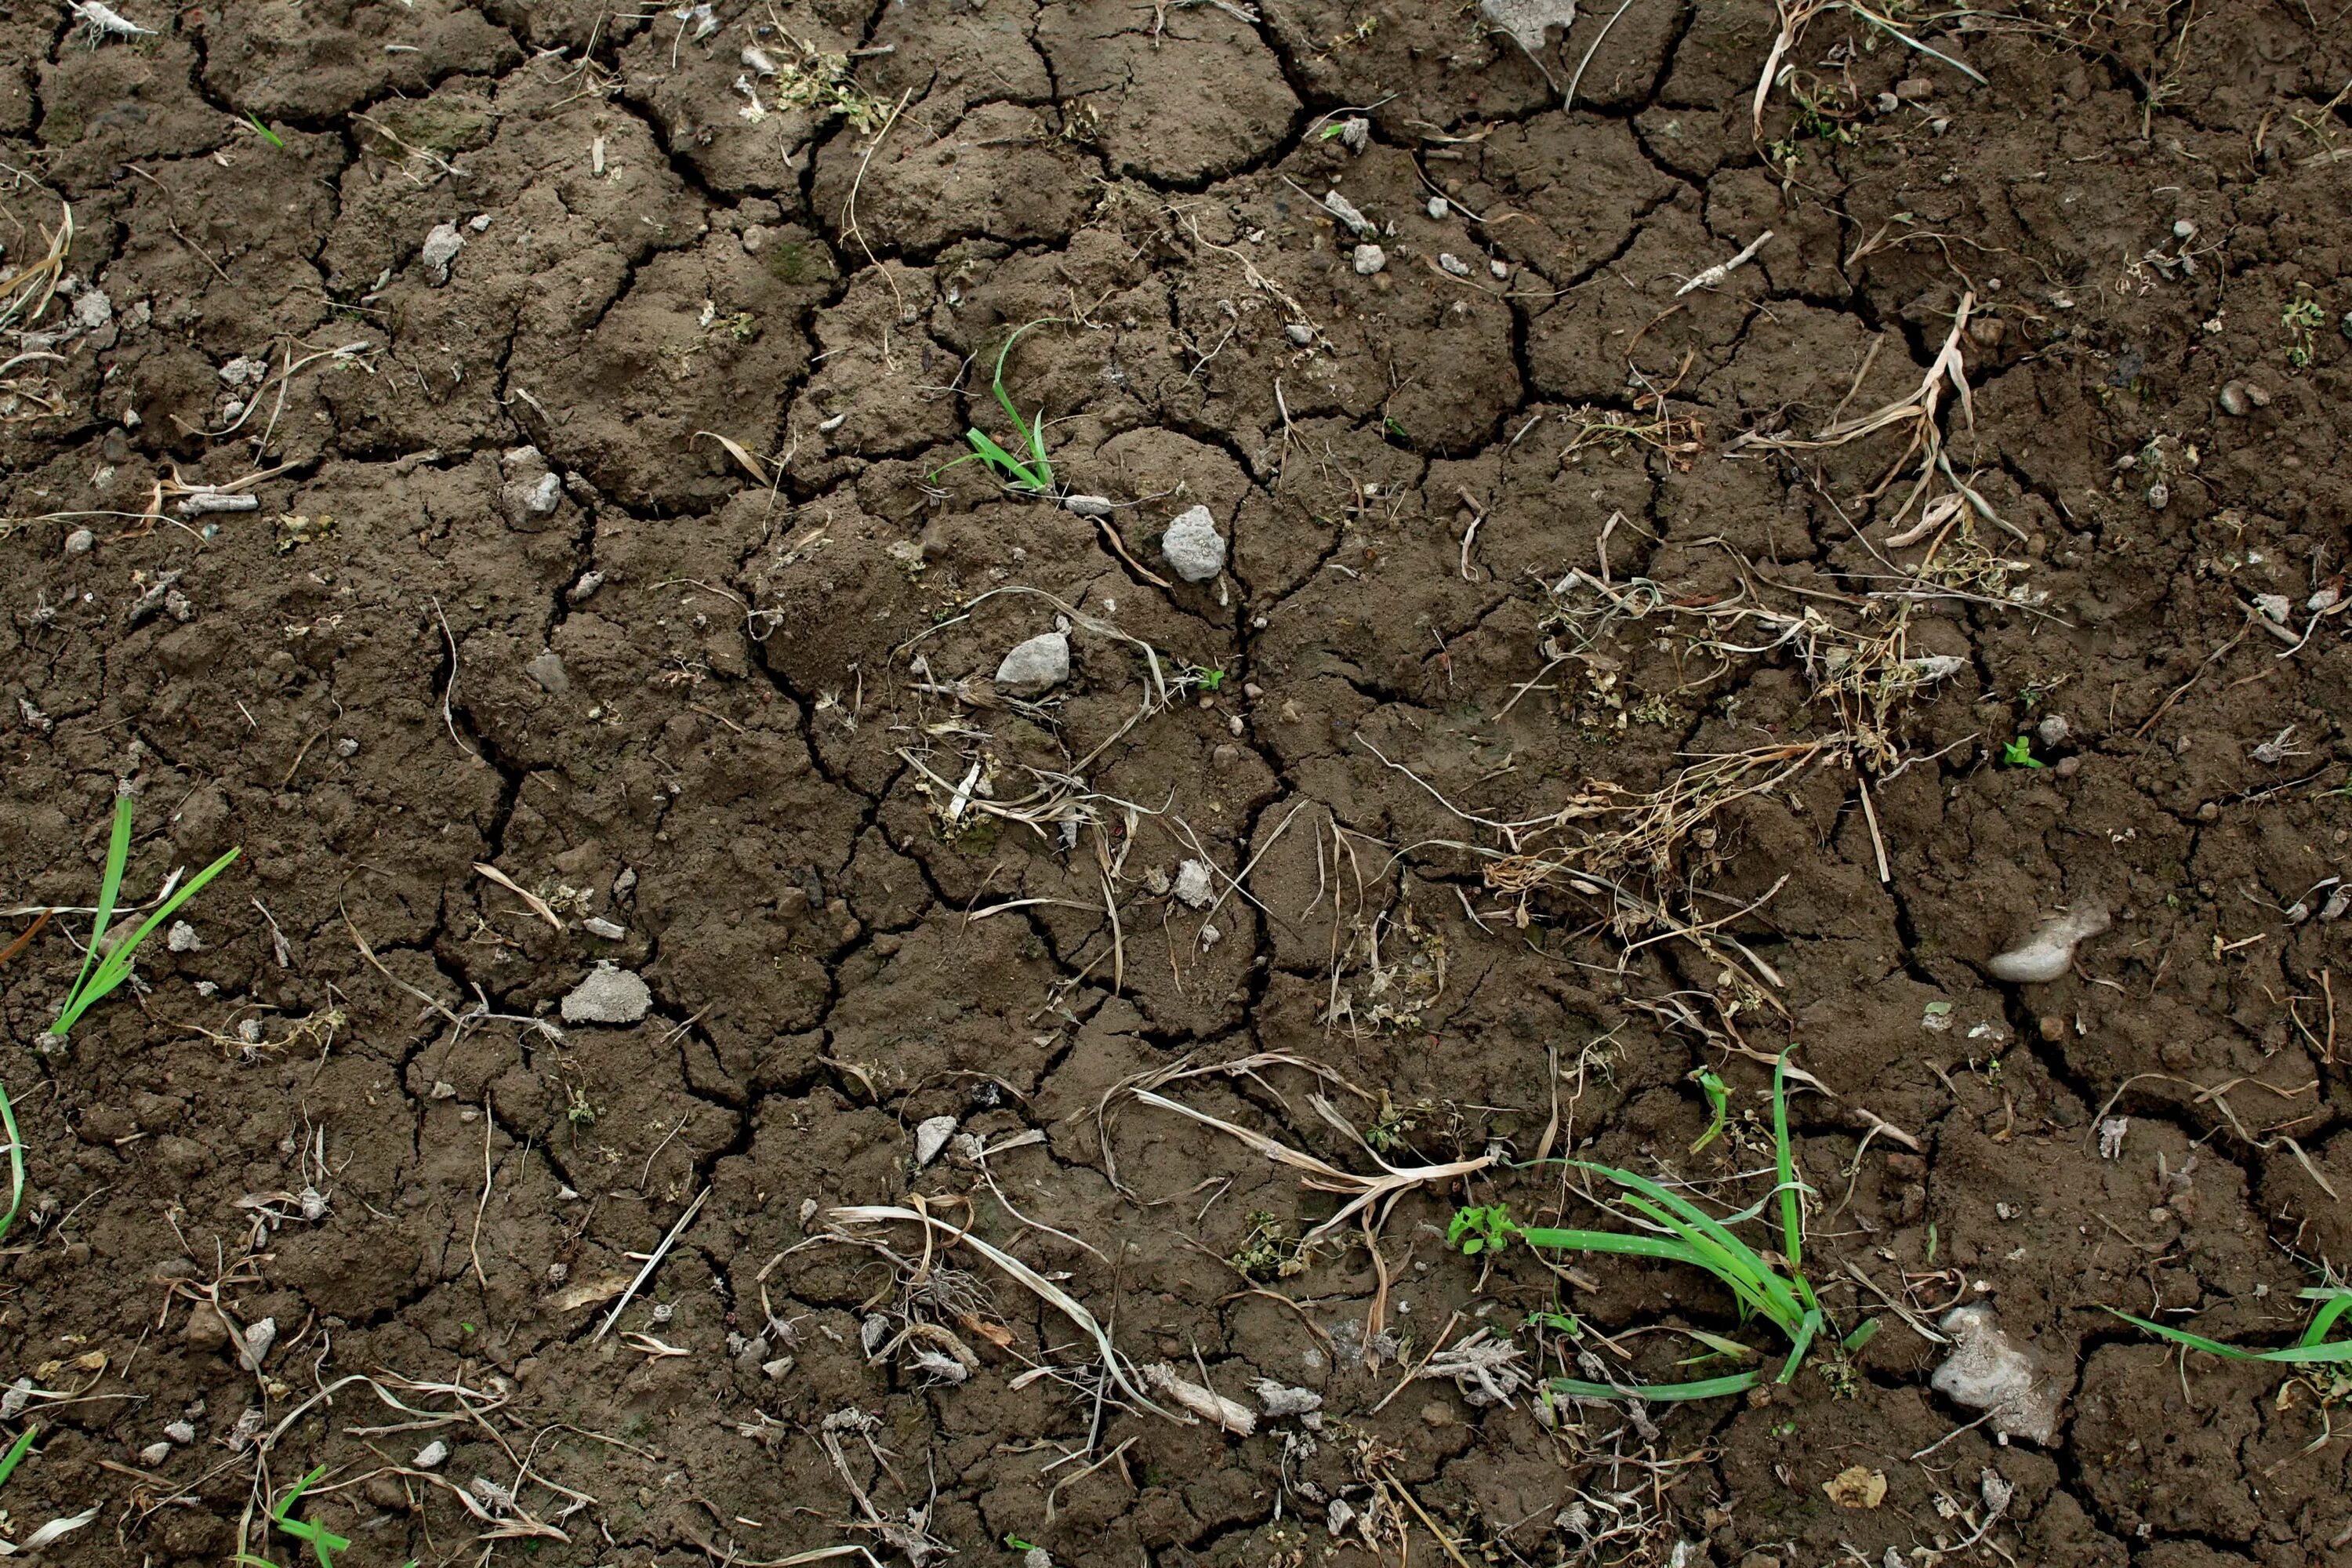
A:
[1449, 1055, 1877, 1403]
